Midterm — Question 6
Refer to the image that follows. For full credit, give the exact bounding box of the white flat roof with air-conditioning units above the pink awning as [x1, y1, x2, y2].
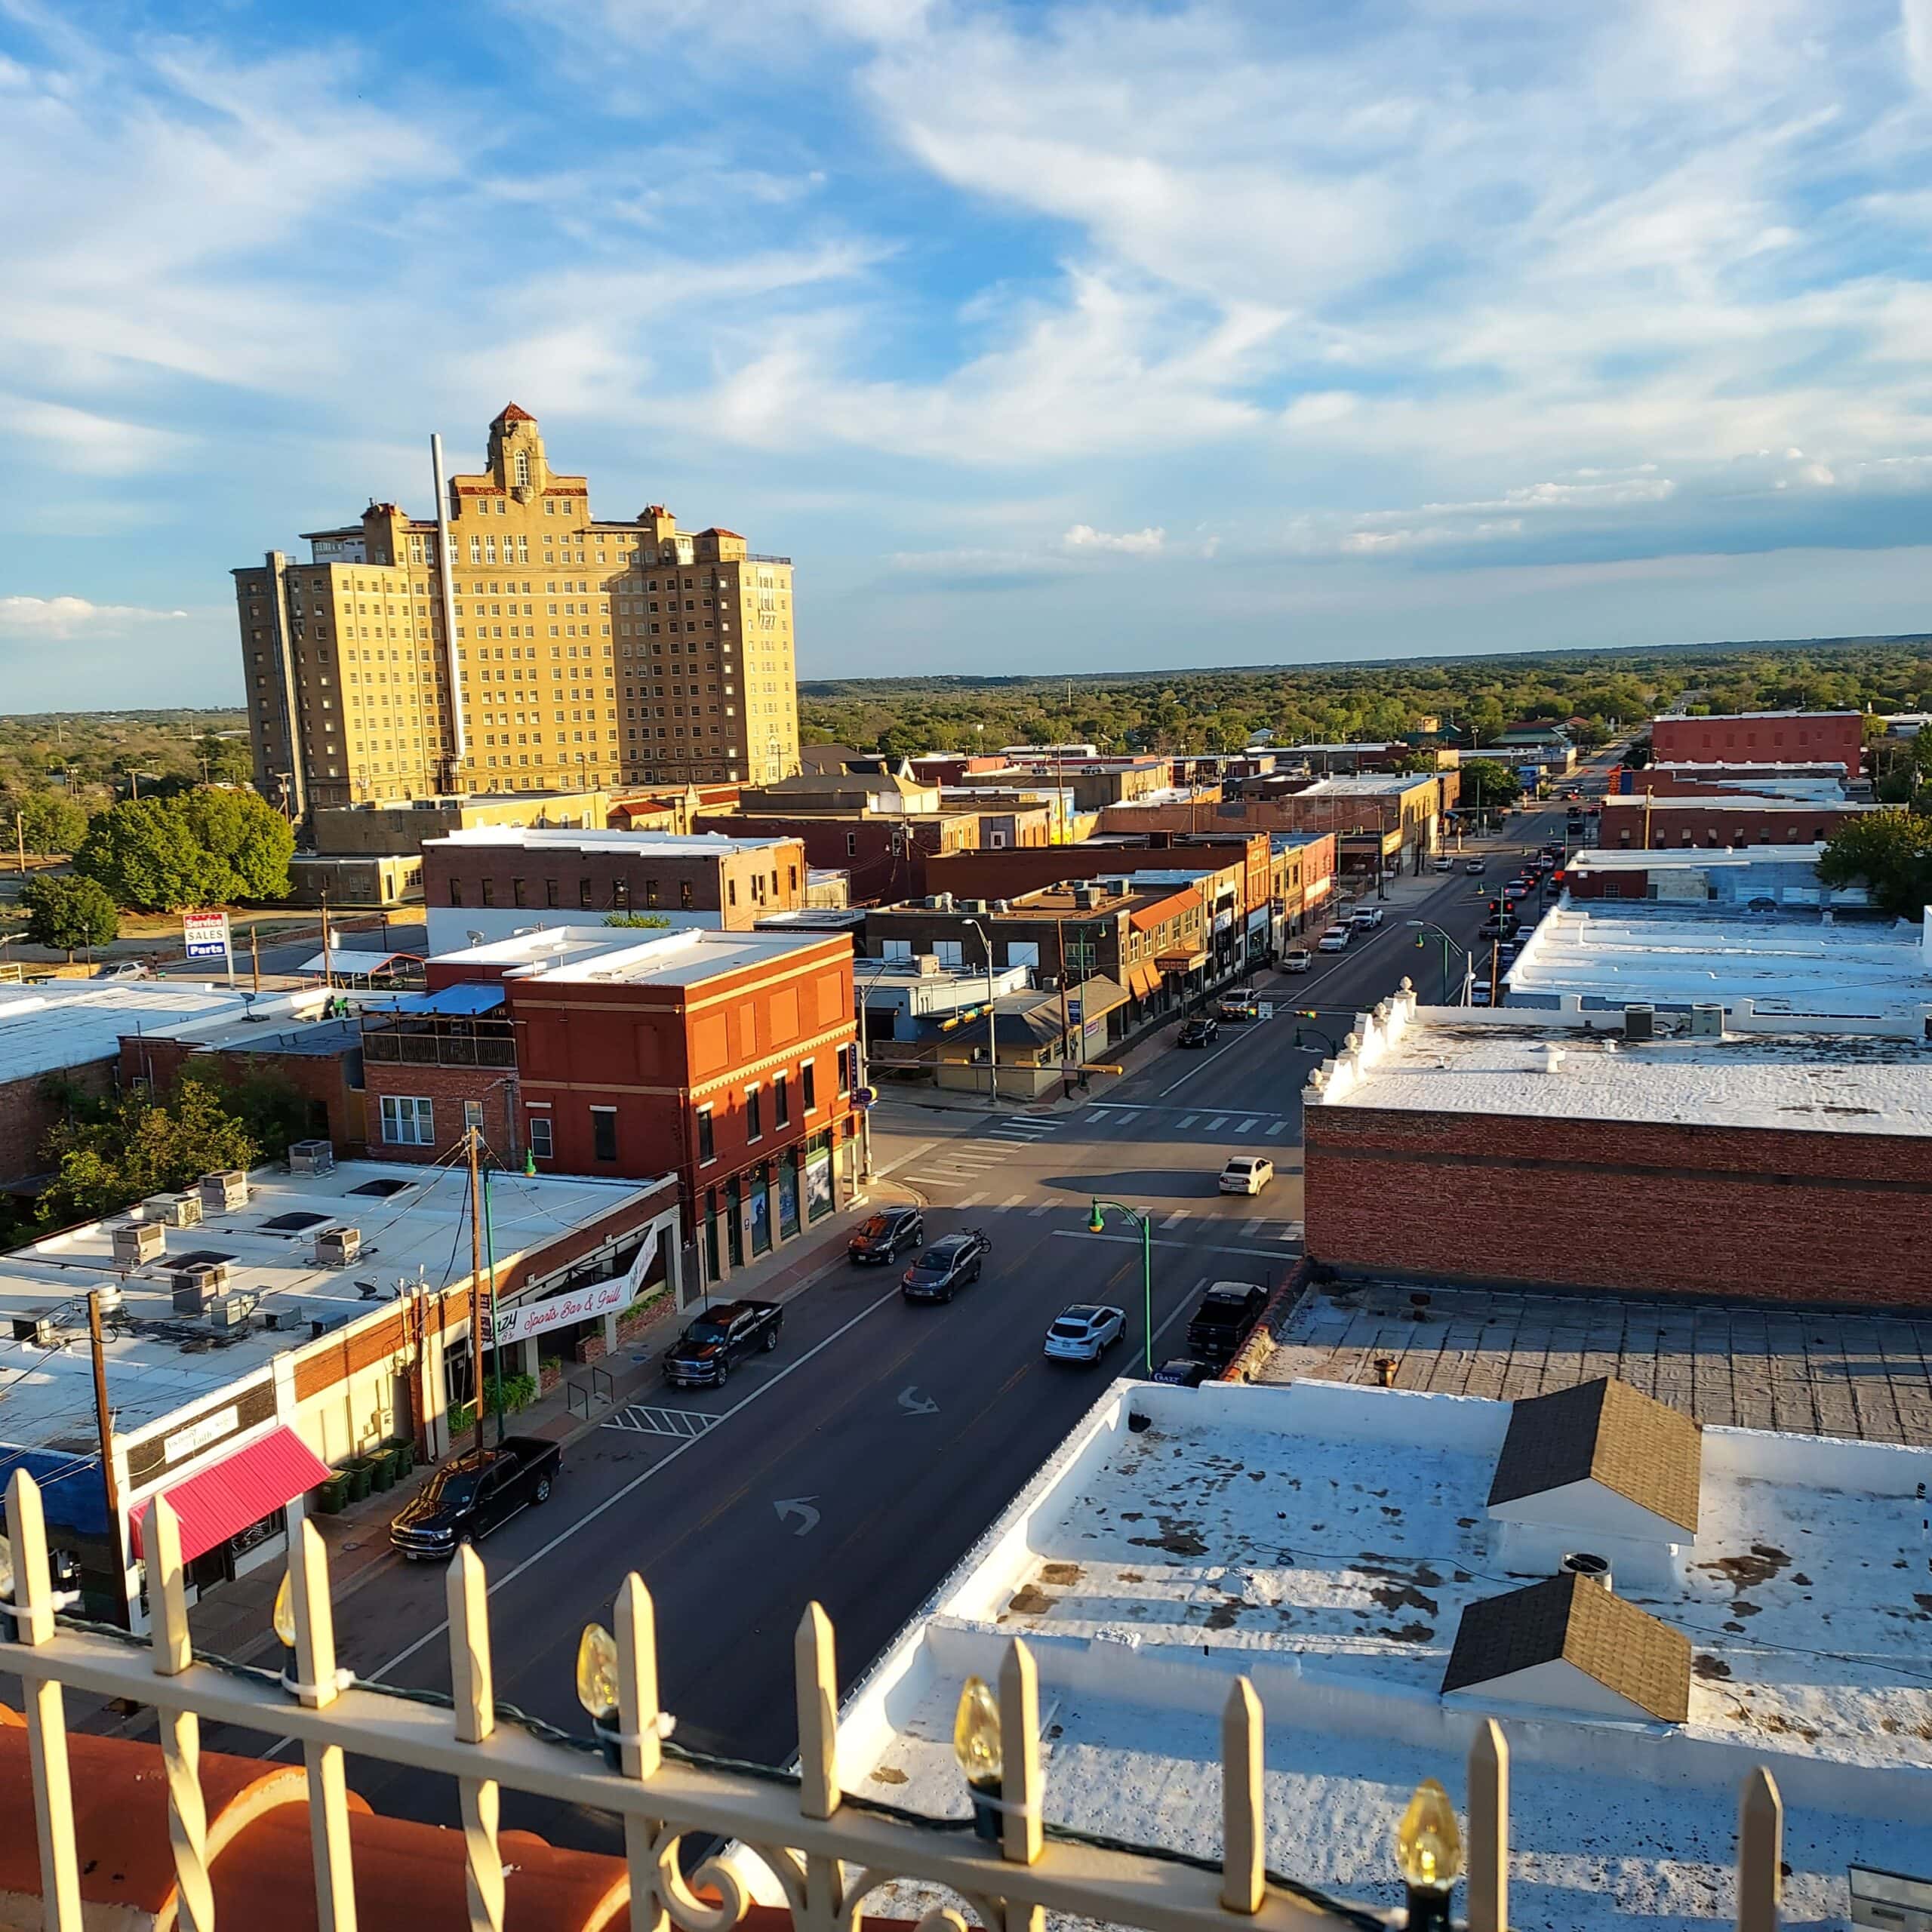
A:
[0, 1161, 663, 1447]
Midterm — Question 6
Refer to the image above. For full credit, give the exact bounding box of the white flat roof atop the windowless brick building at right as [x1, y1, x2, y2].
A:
[1319, 1007, 1932, 1136]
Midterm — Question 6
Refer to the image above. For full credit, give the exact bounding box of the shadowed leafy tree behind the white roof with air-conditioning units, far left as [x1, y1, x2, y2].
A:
[37, 1080, 259, 1227]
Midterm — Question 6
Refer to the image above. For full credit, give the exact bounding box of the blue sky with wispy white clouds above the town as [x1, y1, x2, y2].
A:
[0, 0, 1932, 711]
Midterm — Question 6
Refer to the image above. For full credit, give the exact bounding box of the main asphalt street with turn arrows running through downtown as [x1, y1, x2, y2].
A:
[181, 764, 1607, 1843]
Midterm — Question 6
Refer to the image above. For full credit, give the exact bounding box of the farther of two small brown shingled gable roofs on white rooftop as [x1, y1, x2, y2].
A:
[1490, 1376, 1704, 1536]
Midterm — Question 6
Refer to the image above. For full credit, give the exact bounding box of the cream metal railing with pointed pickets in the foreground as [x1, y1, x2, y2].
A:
[0, 1470, 1783, 1932]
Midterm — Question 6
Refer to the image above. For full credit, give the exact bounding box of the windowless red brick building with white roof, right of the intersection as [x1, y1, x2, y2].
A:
[1304, 997, 1932, 1308]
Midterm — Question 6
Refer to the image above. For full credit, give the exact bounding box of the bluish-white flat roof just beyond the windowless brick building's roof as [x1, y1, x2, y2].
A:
[1509, 908, 1932, 1018]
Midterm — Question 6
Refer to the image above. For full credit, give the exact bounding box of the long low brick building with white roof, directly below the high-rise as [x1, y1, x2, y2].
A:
[423, 825, 806, 952]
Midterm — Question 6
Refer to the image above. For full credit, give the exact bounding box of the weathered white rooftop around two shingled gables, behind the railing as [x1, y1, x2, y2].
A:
[823, 1381, 1932, 1932]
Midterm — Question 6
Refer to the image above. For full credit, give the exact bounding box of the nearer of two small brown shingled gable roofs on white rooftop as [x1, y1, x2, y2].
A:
[1443, 1577, 1690, 1724]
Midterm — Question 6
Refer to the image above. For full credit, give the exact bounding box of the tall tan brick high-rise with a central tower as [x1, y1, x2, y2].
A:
[234, 401, 798, 815]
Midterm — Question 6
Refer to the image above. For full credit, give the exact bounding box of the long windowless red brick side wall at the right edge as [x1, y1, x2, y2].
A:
[1304, 1105, 1932, 1308]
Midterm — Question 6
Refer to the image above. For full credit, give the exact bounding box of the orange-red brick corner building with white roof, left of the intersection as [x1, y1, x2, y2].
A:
[415, 928, 856, 1281]
